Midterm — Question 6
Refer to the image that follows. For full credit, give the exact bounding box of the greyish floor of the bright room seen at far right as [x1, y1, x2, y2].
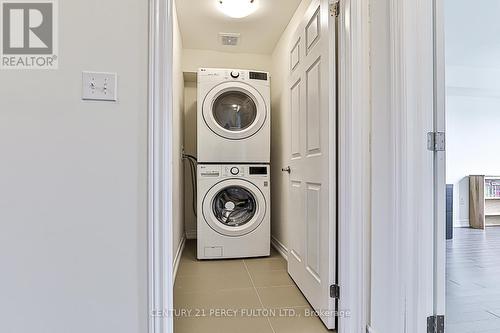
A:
[446, 227, 500, 333]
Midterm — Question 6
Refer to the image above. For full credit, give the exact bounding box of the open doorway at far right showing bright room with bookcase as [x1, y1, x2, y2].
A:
[444, 0, 500, 332]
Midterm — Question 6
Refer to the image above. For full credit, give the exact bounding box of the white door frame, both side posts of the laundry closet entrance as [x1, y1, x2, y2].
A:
[147, 0, 371, 333]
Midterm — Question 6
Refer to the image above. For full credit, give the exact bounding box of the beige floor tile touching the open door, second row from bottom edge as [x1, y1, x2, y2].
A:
[257, 286, 309, 308]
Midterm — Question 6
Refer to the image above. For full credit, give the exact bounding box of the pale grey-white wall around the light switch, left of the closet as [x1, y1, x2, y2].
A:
[0, 0, 148, 333]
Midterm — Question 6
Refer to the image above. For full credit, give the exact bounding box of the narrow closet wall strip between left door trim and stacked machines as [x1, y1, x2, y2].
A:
[172, 1, 184, 264]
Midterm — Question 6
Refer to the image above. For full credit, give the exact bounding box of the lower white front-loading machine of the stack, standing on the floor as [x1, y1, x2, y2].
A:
[197, 164, 271, 259]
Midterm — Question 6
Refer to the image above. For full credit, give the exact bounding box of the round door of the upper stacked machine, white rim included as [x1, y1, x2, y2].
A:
[203, 82, 268, 140]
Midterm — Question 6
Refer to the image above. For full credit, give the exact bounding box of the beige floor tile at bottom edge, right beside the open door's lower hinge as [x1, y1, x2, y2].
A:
[269, 307, 334, 333]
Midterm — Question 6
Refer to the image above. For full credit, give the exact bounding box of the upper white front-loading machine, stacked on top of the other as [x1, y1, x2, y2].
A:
[197, 68, 271, 163]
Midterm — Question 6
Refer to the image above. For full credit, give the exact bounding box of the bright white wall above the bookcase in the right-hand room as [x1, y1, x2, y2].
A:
[445, 0, 500, 226]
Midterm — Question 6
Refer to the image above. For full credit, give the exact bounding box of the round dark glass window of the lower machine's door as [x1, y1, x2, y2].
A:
[212, 186, 257, 227]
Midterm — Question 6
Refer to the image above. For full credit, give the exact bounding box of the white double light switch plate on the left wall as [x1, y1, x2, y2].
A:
[82, 72, 118, 102]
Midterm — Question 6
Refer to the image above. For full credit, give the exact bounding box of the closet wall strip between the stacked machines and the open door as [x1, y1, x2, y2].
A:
[271, 0, 311, 247]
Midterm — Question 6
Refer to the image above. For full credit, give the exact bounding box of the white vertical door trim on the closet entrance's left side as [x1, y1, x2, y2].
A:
[148, 0, 173, 333]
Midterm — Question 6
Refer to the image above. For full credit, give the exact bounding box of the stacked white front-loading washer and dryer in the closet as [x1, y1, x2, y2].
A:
[197, 68, 271, 259]
